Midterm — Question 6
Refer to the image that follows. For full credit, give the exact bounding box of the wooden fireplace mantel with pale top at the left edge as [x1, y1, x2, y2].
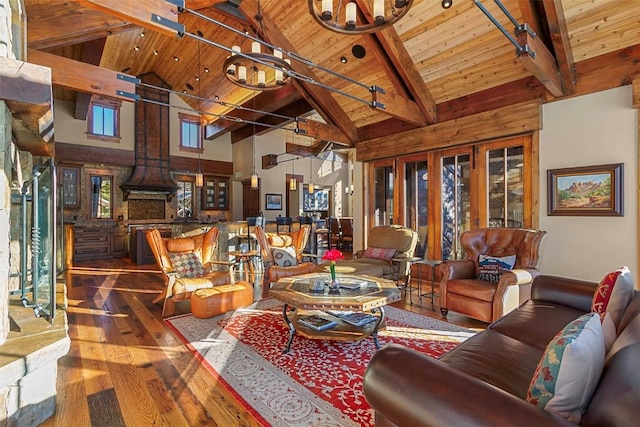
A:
[0, 57, 55, 157]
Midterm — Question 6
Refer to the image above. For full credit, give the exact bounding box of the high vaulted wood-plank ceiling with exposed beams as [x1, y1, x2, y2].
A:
[25, 0, 640, 156]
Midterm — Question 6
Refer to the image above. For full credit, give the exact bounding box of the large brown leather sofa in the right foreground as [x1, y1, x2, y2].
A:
[364, 275, 640, 427]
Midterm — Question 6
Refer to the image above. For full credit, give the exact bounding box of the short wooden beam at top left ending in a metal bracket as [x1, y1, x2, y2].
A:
[76, 0, 178, 37]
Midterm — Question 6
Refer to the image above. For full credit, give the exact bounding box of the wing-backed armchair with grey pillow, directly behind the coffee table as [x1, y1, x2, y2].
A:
[253, 224, 315, 295]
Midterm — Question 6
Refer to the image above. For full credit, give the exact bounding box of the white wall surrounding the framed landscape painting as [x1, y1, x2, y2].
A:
[539, 86, 640, 281]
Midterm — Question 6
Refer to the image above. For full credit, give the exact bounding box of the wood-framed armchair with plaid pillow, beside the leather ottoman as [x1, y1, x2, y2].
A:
[146, 227, 232, 316]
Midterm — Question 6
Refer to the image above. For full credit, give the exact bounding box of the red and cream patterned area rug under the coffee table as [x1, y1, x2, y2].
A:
[165, 299, 475, 426]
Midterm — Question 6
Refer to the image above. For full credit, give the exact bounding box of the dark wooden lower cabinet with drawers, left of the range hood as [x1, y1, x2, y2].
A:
[73, 225, 127, 262]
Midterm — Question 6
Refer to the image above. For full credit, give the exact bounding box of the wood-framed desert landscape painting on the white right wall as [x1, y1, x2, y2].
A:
[547, 163, 624, 216]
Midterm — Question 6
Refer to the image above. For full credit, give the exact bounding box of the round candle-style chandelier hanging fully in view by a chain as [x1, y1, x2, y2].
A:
[222, 1, 292, 90]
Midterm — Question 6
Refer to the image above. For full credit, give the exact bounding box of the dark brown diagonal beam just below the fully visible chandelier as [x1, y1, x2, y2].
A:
[204, 85, 301, 139]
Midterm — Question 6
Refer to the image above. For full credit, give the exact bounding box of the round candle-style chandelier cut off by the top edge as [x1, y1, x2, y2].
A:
[308, 0, 413, 34]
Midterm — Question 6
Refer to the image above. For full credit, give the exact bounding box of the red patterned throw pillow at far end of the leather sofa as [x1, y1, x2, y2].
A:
[591, 266, 633, 327]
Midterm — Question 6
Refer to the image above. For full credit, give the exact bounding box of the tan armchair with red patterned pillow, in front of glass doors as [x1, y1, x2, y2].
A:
[316, 225, 418, 280]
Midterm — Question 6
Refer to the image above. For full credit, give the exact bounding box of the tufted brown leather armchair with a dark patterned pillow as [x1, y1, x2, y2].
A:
[438, 228, 546, 322]
